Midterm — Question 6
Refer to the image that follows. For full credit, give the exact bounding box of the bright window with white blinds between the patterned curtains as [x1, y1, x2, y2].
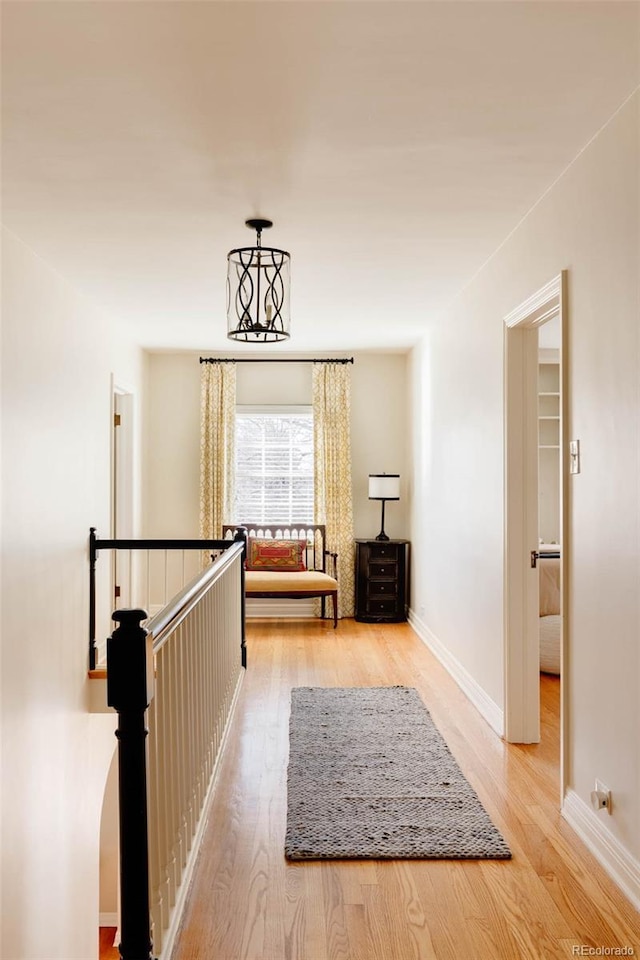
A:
[235, 407, 314, 523]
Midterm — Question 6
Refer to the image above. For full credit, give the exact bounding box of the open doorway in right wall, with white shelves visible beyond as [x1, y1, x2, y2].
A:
[504, 272, 569, 789]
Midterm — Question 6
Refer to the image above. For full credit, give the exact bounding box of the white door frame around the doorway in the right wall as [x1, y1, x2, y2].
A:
[504, 270, 570, 786]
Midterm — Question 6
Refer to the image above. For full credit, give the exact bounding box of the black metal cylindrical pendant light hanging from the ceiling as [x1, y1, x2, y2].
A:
[227, 220, 291, 343]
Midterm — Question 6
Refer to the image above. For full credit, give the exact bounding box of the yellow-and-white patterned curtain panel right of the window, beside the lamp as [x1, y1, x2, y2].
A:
[313, 363, 355, 617]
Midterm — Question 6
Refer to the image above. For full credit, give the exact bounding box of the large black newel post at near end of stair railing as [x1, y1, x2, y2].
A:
[107, 610, 153, 960]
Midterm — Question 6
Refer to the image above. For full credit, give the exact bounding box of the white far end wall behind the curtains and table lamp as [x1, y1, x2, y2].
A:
[144, 353, 410, 537]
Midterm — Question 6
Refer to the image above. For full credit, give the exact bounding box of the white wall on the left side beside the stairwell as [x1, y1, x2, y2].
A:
[1, 232, 142, 960]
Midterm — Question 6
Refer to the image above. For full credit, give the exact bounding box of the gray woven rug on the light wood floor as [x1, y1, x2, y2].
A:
[285, 687, 511, 860]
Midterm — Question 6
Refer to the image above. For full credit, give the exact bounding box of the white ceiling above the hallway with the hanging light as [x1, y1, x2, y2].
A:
[2, 0, 640, 352]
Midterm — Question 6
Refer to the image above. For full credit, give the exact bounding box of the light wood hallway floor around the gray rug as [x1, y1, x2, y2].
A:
[168, 620, 640, 960]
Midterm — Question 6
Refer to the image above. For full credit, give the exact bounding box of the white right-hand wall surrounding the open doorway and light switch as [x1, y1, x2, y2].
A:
[412, 95, 640, 869]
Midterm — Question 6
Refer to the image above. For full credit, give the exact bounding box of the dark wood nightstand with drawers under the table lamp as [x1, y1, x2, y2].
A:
[355, 540, 409, 623]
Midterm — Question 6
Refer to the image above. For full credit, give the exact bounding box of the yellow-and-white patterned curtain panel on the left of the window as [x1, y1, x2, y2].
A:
[200, 363, 236, 540]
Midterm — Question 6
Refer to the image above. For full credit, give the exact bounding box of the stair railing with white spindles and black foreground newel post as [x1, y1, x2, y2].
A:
[107, 543, 245, 960]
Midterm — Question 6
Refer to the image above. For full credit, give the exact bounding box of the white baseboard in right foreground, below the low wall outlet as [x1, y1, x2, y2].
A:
[562, 790, 640, 910]
